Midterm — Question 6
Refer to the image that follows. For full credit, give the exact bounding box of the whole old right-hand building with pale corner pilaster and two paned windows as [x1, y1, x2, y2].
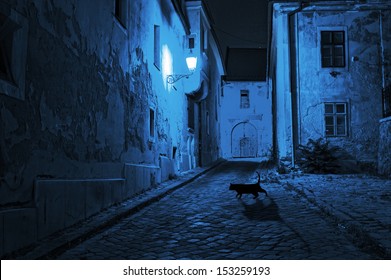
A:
[268, 1, 391, 174]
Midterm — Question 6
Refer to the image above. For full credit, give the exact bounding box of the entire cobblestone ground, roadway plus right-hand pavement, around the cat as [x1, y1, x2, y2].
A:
[45, 161, 391, 259]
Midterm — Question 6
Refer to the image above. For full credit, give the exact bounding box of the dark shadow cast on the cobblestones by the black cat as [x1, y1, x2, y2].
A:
[240, 197, 281, 221]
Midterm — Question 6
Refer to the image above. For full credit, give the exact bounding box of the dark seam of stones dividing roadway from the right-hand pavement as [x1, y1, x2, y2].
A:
[284, 181, 391, 259]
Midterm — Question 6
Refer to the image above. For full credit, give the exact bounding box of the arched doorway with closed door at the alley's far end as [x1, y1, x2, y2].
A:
[231, 122, 258, 158]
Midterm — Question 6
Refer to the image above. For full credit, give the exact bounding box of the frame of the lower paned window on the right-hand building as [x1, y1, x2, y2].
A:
[323, 101, 349, 137]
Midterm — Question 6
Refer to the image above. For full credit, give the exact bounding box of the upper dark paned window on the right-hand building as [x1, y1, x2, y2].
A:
[320, 31, 345, 68]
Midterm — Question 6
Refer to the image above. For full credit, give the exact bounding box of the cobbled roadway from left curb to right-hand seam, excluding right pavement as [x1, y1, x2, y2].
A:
[42, 161, 391, 259]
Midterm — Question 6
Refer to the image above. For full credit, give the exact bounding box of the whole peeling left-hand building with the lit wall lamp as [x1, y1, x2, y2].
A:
[0, 0, 224, 255]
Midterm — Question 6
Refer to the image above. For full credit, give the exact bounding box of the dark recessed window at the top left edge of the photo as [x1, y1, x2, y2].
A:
[0, 2, 28, 100]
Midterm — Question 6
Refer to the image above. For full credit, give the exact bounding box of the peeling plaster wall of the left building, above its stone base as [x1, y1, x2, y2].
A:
[0, 0, 194, 207]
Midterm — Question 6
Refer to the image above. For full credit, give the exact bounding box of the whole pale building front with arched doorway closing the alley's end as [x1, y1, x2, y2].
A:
[219, 81, 272, 158]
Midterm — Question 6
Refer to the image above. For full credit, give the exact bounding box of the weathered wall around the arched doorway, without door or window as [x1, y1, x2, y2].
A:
[221, 82, 272, 158]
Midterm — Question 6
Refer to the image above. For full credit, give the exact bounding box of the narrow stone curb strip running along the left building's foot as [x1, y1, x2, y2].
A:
[7, 159, 226, 260]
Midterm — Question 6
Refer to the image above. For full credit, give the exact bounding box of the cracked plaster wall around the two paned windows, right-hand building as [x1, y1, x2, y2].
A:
[298, 11, 390, 164]
